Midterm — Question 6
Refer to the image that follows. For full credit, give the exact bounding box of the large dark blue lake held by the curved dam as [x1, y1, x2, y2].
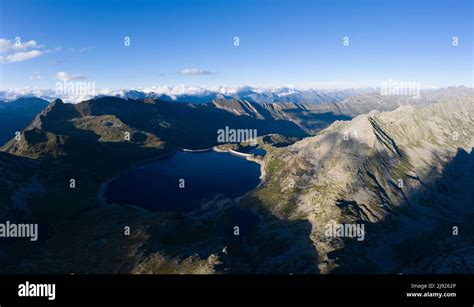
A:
[105, 151, 260, 212]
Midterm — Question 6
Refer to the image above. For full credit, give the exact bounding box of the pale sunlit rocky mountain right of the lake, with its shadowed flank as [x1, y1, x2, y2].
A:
[264, 96, 474, 273]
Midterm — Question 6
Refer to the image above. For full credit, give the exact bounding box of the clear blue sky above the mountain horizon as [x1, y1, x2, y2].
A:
[0, 0, 473, 89]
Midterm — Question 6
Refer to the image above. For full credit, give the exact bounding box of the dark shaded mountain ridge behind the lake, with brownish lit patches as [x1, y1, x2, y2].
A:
[2, 97, 306, 172]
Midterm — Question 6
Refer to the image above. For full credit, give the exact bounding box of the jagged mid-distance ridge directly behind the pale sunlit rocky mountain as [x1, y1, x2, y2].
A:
[210, 86, 474, 135]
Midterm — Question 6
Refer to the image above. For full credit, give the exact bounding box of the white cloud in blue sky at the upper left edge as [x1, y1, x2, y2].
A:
[0, 38, 61, 64]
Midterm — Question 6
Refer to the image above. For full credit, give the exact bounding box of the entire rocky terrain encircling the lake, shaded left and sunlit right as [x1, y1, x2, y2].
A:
[0, 91, 474, 273]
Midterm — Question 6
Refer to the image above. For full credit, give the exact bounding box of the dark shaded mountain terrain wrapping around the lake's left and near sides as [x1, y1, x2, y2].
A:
[0, 98, 315, 273]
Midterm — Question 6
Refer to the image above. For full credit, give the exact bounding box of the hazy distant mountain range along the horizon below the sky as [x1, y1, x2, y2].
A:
[0, 87, 474, 145]
